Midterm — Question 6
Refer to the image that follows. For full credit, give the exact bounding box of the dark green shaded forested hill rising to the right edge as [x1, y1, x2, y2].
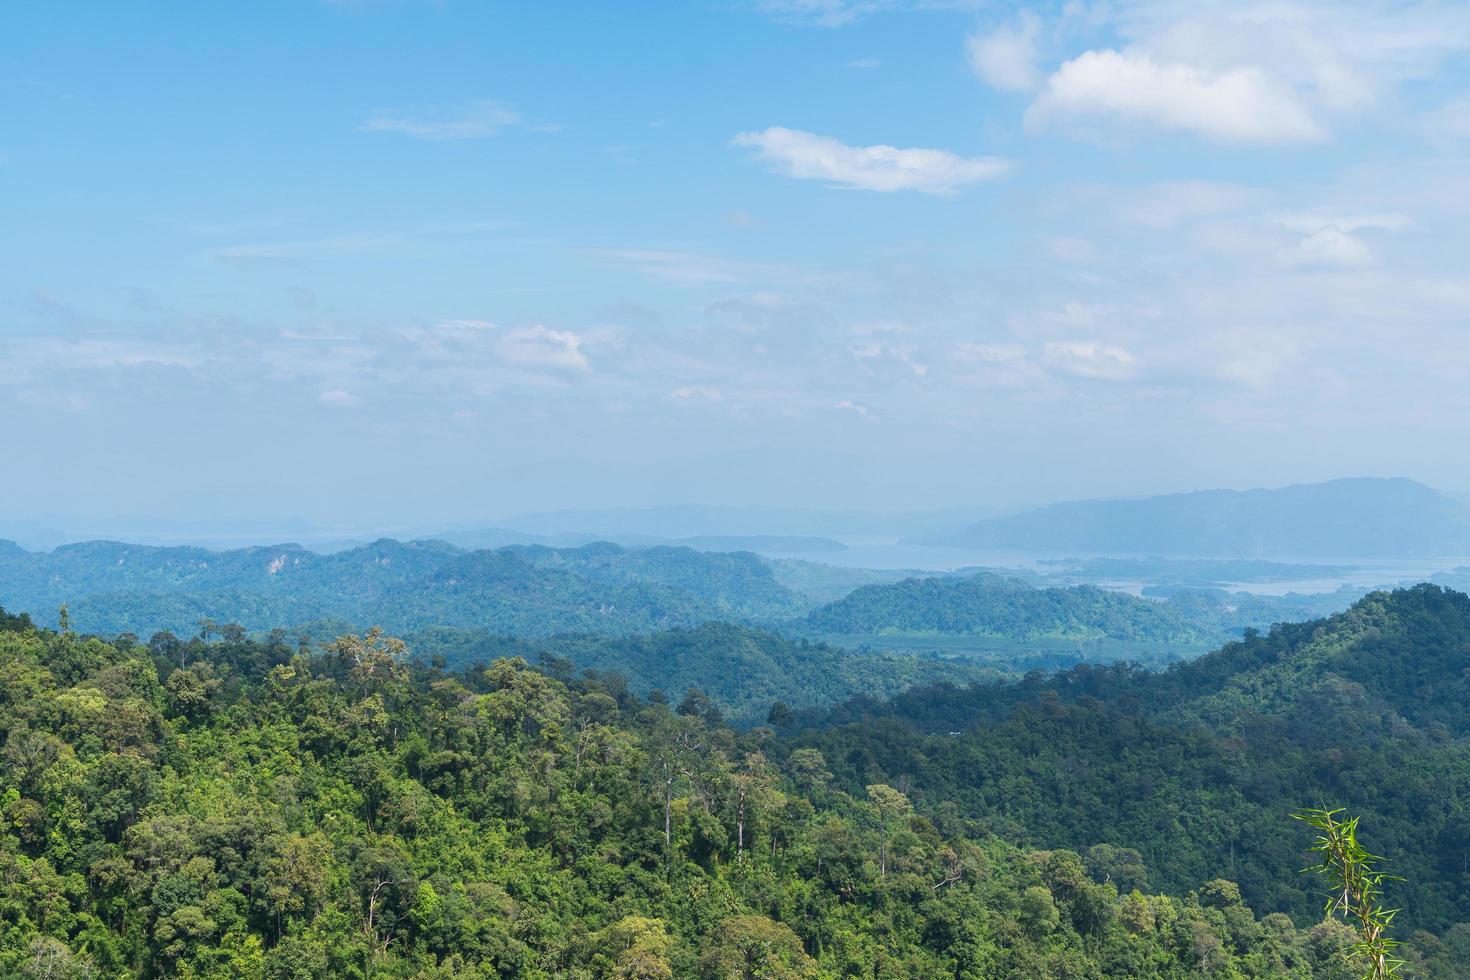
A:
[803, 585, 1470, 940]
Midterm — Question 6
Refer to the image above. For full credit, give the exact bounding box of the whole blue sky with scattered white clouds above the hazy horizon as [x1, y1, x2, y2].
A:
[0, 0, 1470, 523]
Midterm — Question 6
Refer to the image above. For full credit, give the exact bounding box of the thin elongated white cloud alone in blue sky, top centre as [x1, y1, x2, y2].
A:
[732, 126, 1011, 194]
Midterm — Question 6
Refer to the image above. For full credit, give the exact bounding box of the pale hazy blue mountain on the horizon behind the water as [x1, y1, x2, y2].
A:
[913, 479, 1470, 558]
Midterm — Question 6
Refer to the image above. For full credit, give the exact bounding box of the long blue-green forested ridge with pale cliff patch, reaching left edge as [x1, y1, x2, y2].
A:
[0, 539, 809, 636]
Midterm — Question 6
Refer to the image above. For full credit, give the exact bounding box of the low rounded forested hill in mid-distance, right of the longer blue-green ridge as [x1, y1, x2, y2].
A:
[801, 573, 1222, 646]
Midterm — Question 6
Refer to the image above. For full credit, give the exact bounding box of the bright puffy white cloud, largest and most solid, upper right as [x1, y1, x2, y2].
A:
[1026, 50, 1326, 143]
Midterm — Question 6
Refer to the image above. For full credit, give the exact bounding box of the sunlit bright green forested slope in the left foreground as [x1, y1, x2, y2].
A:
[0, 605, 1411, 979]
